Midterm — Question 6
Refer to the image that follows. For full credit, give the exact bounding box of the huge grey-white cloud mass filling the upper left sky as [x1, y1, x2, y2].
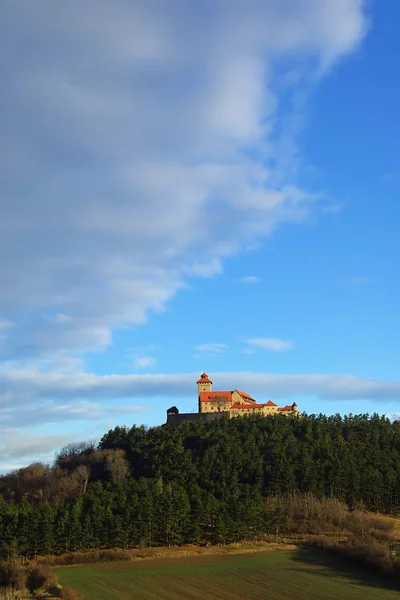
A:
[0, 0, 366, 359]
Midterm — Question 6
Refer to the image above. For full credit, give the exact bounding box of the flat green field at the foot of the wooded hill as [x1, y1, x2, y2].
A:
[55, 550, 400, 600]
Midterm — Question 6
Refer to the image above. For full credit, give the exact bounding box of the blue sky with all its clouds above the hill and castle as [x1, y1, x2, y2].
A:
[0, 0, 400, 471]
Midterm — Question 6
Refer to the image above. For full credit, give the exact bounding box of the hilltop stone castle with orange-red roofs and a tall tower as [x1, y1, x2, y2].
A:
[167, 373, 299, 425]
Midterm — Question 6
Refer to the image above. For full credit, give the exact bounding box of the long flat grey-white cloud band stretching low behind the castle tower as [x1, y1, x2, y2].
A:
[0, 365, 400, 410]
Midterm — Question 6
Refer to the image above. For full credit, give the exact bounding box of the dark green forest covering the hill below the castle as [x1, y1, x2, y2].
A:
[0, 414, 400, 558]
